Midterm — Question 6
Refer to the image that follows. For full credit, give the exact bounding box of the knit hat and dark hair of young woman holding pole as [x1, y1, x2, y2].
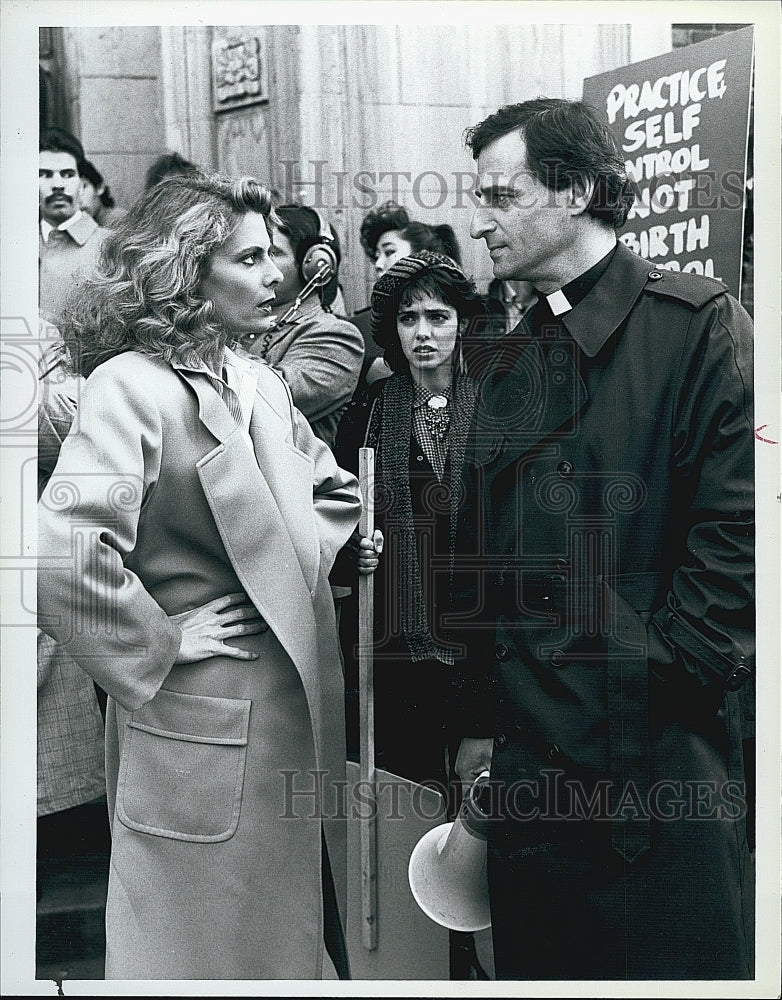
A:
[370, 250, 486, 372]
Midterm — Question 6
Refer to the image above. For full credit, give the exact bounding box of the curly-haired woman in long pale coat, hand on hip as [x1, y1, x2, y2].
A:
[38, 174, 372, 979]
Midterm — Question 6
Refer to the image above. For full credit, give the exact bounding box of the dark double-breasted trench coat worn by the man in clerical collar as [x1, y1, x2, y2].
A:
[461, 245, 754, 979]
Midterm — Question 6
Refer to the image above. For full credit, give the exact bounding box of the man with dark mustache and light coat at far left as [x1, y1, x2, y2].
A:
[38, 128, 108, 326]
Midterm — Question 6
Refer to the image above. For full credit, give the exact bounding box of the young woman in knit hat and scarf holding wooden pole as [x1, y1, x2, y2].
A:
[336, 250, 486, 979]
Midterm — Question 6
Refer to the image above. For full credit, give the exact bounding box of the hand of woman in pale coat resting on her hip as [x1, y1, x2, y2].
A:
[170, 593, 269, 663]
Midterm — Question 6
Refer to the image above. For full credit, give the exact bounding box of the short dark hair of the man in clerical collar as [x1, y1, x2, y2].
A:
[464, 97, 635, 229]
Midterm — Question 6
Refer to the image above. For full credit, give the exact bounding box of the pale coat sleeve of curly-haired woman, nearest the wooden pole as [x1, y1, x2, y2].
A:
[292, 396, 361, 575]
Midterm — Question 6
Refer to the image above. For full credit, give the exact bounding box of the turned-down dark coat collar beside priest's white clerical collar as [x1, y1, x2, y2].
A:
[560, 242, 653, 358]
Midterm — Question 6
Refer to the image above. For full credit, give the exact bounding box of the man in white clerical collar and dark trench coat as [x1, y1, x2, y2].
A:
[452, 98, 755, 981]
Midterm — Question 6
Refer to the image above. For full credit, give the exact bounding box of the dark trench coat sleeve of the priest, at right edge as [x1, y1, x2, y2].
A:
[650, 295, 755, 690]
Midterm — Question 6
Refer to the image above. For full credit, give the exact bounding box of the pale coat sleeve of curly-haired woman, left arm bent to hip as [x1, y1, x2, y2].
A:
[38, 364, 182, 710]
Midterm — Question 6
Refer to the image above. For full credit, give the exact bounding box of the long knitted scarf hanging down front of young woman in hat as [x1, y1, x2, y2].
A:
[364, 372, 475, 663]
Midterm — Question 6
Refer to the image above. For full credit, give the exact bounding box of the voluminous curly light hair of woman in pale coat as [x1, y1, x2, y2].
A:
[61, 171, 277, 376]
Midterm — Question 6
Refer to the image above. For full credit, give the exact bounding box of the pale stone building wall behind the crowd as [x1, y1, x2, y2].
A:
[52, 22, 671, 308]
